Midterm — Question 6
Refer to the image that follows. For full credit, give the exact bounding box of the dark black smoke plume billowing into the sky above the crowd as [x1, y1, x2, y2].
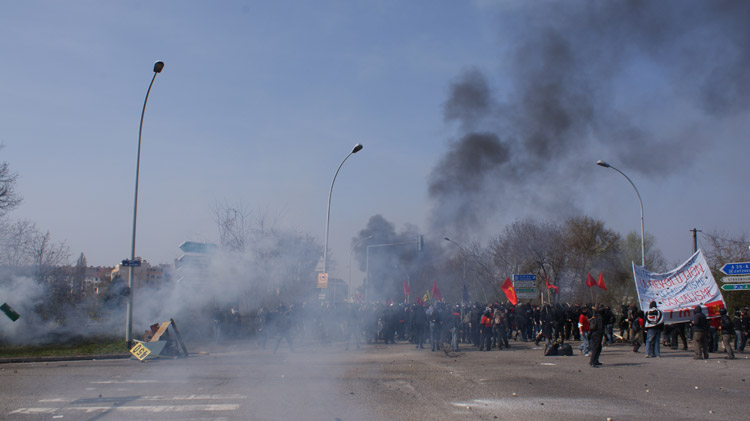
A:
[429, 0, 750, 239]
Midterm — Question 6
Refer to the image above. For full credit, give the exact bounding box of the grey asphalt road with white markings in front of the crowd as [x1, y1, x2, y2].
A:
[0, 342, 750, 420]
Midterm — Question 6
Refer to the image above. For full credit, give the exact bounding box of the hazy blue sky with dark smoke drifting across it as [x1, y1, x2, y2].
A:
[0, 0, 750, 286]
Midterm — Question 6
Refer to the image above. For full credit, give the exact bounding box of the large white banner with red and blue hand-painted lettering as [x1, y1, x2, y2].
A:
[633, 250, 726, 324]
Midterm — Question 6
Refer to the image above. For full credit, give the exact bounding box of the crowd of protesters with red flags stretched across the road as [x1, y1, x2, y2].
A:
[219, 302, 750, 360]
